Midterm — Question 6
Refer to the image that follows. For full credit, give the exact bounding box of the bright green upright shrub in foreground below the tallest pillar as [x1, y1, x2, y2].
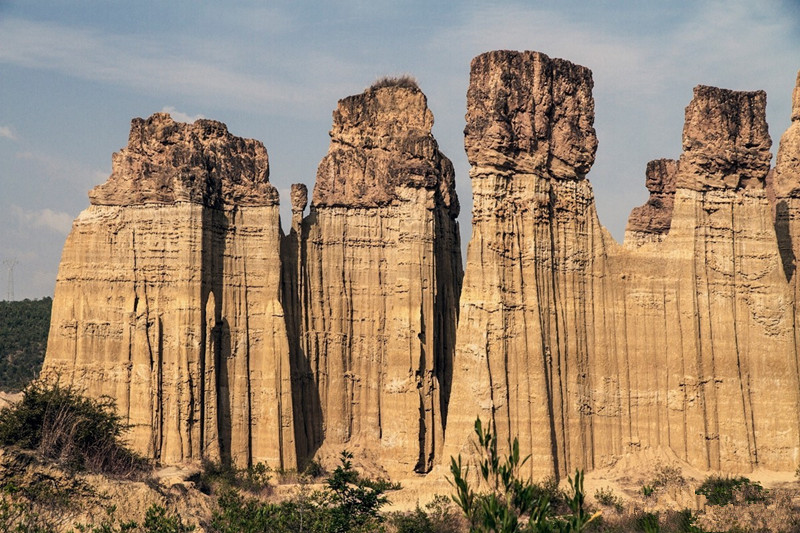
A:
[450, 418, 600, 533]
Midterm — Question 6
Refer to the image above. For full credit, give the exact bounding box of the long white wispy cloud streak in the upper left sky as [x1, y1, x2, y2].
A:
[0, 17, 358, 117]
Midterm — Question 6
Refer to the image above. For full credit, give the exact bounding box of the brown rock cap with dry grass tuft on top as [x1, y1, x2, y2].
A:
[312, 82, 459, 216]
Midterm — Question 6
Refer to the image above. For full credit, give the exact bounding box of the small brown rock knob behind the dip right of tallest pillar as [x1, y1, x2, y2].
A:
[625, 159, 678, 247]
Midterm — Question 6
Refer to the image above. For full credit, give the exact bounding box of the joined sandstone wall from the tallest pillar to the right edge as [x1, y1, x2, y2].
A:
[443, 52, 800, 476]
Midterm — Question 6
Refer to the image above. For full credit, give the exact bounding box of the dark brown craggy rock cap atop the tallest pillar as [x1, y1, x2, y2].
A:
[464, 50, 597, 179]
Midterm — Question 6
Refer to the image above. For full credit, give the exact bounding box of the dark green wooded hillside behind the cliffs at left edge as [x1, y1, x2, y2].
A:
[0, 298, 53, 391]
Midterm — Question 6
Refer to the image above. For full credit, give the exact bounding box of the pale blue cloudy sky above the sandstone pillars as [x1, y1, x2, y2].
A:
[0, 0, 800, 299]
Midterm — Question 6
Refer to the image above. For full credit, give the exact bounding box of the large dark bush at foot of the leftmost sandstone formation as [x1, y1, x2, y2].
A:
[0, 382, 148, 477]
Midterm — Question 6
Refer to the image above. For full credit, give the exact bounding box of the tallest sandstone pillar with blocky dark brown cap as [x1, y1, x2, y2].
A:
[444, 51, 613, 474]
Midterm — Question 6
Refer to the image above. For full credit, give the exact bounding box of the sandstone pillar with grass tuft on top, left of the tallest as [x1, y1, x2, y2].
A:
[300, 82, 462, 473]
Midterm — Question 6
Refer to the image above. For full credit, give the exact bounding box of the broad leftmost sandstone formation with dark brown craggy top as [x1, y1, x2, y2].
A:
[43, 114, 296, 468]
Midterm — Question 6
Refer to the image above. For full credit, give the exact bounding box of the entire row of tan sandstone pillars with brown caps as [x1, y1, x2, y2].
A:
[43, 55, 800, 478]
